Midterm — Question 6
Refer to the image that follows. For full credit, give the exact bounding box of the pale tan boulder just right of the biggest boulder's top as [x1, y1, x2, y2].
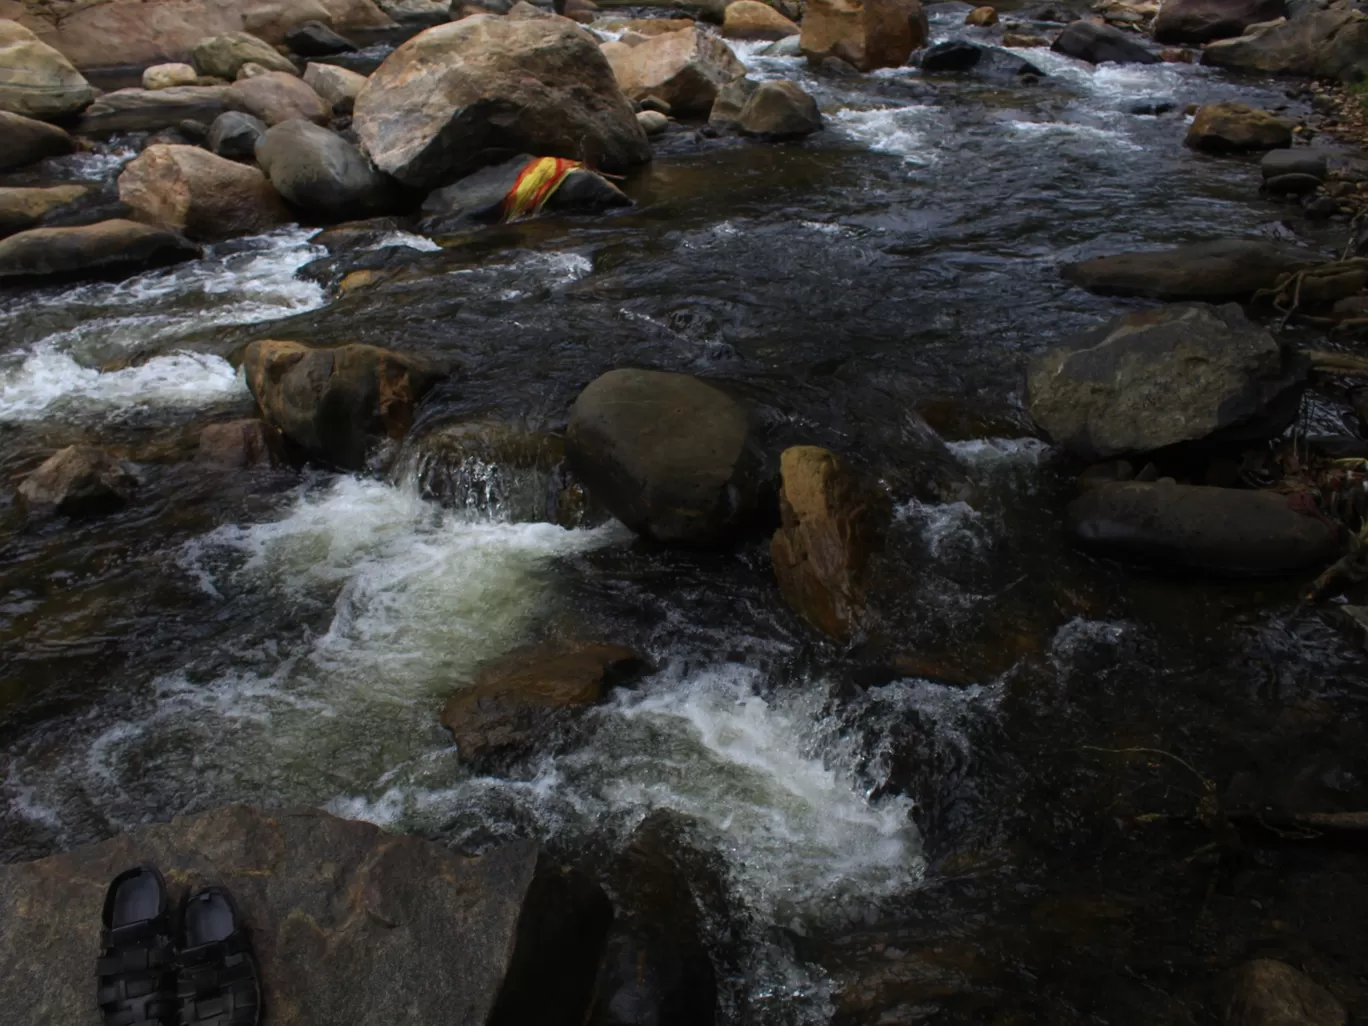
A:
[609, 27, 746, 115]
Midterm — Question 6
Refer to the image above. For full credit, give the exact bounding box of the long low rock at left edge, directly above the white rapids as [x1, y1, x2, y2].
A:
[0, 219, 200, 279]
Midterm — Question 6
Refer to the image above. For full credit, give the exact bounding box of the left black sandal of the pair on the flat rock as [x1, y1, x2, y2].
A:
[96, 866, 176, 1026]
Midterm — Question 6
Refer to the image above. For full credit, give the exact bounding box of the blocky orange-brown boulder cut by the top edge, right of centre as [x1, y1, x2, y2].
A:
[799, 0, 930, 71]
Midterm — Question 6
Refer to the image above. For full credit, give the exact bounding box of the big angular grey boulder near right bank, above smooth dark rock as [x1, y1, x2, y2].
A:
[1027, 304, 1306, 461]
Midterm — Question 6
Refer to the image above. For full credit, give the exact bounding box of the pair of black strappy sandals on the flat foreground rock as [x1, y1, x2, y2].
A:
[96, 866, 261, 1026]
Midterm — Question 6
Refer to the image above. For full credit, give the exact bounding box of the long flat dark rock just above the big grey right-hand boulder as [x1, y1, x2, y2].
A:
[1062, 239, 1323, 301]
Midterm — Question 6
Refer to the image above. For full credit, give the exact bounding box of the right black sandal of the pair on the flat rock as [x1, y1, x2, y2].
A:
[176, 886, 261, 1026]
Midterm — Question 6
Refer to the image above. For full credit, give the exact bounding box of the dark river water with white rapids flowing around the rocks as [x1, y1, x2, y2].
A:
[0, 5, 1368, 1023]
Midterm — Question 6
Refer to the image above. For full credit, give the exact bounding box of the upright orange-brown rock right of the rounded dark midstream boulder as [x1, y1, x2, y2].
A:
[770, 446, 892, 642]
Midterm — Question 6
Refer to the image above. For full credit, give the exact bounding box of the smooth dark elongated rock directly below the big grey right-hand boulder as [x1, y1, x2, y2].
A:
[1068, 482, 1345, 576]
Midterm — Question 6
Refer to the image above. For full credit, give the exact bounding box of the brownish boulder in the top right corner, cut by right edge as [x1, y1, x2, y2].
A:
[1201, 8, 1368, 82]
